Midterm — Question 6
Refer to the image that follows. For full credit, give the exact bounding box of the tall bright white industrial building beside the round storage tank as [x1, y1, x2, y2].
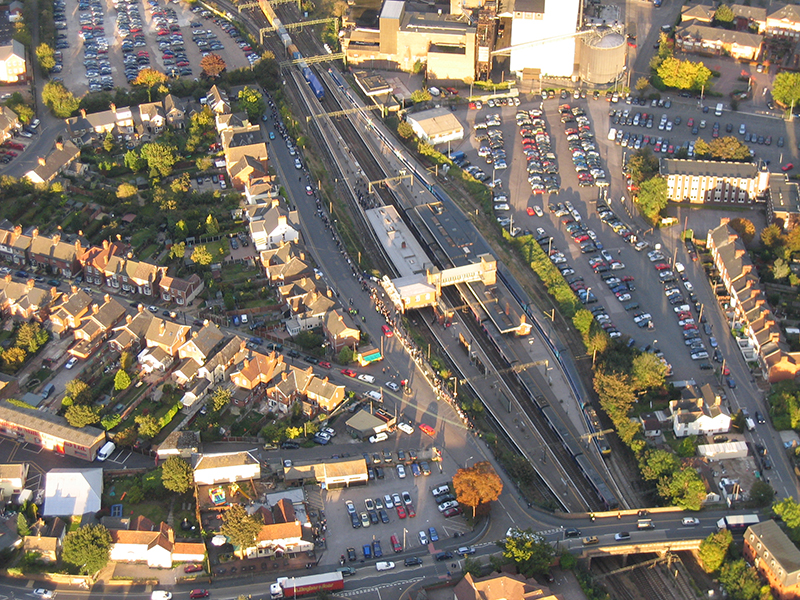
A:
[499, 0, 579, 77]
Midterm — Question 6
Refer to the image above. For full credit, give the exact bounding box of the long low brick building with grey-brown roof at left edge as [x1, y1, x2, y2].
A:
[0, 401, 106, 461]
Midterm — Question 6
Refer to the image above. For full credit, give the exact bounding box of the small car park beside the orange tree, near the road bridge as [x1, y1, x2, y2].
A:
[324, 440, 470, 566]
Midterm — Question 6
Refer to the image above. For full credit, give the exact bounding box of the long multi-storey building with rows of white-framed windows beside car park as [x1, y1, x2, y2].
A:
[660, 158, 770, 204]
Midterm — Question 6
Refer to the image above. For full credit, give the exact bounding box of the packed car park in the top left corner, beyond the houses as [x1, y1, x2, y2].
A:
[54, 0, 250, 95]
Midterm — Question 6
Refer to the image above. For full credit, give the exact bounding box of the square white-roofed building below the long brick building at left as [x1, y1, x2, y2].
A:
[42, 469, 103, 517]
